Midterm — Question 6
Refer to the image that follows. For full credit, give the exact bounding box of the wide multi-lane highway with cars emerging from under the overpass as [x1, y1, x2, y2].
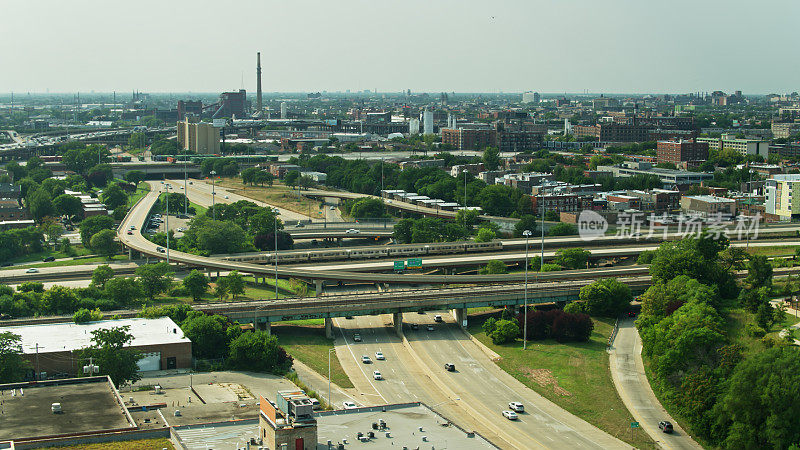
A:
[336, 313, 629, 449]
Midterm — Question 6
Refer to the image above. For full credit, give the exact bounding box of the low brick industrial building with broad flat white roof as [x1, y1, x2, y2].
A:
[0, 317, 192, 379]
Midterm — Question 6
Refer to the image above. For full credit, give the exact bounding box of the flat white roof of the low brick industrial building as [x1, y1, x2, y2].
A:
[0, 317, 191, 354]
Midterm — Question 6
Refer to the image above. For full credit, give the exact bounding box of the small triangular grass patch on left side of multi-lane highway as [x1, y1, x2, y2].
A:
[271, 319, 353, 389]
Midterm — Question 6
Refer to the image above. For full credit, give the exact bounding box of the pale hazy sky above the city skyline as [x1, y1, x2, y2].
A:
[0, 0, 800, 94]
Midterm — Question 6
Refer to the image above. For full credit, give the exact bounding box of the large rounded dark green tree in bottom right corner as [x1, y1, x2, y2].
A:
[719, 346, 800, 448]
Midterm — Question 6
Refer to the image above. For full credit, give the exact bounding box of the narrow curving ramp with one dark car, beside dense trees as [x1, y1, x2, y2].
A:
[609, 318, 703, 449]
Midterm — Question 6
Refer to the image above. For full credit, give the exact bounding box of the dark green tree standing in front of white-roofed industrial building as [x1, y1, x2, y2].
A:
[83, 325, 142, 388]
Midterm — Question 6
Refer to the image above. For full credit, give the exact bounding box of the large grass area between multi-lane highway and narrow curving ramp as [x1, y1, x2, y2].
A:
[469, 314, 654, 448]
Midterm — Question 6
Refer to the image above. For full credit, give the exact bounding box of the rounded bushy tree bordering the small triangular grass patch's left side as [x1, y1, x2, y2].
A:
[229, 331, 293, 375]
